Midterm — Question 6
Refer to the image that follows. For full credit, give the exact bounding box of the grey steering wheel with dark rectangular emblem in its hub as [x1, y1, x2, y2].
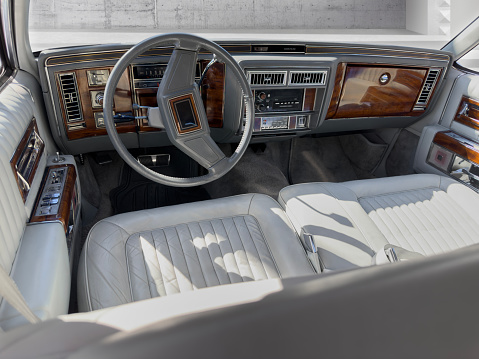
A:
[103, 34, 254, 187]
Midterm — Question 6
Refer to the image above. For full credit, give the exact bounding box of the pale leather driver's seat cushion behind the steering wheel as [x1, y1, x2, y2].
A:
[78, 194, 314, 311]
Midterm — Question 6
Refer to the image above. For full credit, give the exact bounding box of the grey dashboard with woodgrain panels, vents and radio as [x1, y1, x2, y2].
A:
[38, 42, 451, 154]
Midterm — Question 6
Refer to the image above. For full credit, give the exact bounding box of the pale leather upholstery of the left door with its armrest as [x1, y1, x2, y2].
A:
[0, 76, 70, 330]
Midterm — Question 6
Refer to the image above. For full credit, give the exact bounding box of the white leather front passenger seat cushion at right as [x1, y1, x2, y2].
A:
[279, 174, 479, 270]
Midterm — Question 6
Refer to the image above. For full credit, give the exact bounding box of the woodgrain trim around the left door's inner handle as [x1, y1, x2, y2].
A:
[10, 118, 45, 202]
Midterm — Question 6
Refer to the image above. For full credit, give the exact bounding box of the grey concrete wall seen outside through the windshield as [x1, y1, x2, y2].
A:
[30, 0, 406, 30]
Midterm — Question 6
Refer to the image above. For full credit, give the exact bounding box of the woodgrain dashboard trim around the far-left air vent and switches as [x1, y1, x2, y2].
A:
[55, 66, 136, 140]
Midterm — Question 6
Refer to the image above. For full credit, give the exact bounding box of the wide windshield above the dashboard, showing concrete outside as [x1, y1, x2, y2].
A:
[30, 0, 479, 51]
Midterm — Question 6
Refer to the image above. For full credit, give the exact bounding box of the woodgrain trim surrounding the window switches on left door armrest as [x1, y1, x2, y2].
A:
[30, 164, 77, 232]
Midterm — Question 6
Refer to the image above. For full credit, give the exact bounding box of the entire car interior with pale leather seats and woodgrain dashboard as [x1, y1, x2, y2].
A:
[0, 0, 479, 358]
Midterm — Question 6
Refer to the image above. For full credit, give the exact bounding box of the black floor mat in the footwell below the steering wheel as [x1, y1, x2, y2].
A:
[110, 164, 210, 214]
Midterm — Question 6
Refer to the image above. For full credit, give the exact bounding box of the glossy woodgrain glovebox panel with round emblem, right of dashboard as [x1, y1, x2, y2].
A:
[328, 63, 428, 118]
